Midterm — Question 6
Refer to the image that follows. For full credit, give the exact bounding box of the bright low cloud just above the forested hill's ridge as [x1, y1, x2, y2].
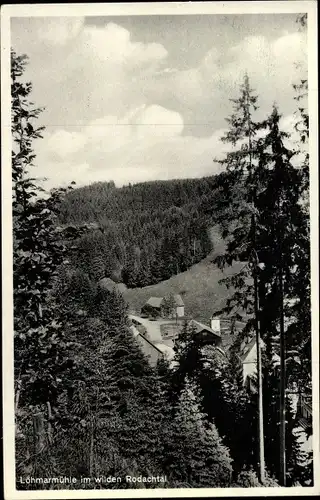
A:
[36, 104, 225, 188]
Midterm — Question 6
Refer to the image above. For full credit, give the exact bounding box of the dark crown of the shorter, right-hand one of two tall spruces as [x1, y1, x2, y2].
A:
[257, 107, 311, 385]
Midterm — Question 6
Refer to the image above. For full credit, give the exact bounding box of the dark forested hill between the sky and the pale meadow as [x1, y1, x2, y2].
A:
[60, 176, 222, 287]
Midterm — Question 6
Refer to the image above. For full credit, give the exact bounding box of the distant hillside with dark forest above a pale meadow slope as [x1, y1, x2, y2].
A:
[57, 176, 250, 323]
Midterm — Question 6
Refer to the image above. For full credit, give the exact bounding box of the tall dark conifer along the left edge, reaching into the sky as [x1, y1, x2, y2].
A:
[11, 51, 92, 484]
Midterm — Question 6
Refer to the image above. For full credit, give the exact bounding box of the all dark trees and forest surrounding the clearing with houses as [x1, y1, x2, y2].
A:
[11, 37, 311, 489]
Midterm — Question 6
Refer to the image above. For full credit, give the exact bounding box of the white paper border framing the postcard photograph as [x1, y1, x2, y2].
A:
[1, 0, 320, 500]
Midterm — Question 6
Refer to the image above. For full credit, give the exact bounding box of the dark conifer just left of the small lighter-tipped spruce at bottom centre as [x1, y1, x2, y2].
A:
[94, 296, 169, 474]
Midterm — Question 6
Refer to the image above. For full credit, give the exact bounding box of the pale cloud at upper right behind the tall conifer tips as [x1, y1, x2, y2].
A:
[152, 32, 307, 127]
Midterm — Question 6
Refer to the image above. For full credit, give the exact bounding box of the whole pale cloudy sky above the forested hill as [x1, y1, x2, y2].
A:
[11, 14, 307, 188]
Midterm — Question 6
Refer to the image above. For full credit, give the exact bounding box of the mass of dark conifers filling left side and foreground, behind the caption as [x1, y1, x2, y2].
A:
[11, 52, 238, 489]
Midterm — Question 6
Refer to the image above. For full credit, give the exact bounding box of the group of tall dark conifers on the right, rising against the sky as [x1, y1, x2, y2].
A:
[206, 71, 311, 484]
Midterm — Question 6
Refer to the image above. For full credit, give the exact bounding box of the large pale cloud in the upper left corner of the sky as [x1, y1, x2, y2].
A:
[13, 18, 168, 128]
